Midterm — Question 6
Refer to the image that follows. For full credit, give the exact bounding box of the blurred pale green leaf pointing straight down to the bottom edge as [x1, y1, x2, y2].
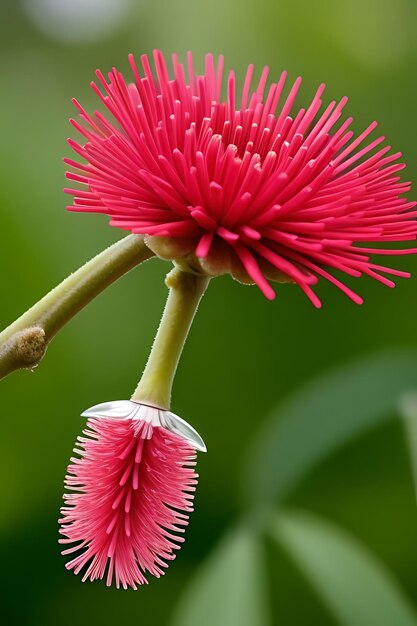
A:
[172, 527, 269, 626]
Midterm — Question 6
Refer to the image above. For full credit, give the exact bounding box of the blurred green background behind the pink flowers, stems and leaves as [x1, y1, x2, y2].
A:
[0, 0, 417, 626]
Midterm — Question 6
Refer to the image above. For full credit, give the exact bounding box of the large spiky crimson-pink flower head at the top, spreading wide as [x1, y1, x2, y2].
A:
[66, 51, 417, 306]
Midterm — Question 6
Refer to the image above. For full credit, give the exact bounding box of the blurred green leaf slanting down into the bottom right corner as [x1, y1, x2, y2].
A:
[272, 512, 417, 626]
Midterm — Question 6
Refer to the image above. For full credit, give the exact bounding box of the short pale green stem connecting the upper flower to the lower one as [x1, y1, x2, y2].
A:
[132, 266, 210, 409]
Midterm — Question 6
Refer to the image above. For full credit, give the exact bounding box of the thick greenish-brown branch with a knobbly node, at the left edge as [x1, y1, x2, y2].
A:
[0, 235, 154, 379]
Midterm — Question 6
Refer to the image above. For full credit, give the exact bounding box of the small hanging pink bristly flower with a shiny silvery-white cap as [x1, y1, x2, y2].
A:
[59, 400, 206, 589]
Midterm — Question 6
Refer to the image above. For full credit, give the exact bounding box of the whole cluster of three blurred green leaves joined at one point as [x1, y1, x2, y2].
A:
[174, 352, 417, 626]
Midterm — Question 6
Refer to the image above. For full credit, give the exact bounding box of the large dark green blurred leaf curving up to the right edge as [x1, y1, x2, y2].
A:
[243, 351, 417, 505]
